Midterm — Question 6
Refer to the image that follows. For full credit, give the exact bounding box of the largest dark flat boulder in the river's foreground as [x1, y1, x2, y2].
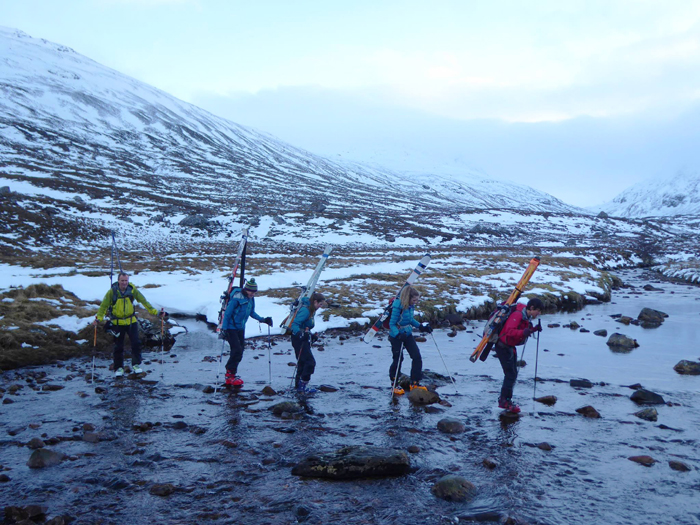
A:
[292, 446, 411, 479]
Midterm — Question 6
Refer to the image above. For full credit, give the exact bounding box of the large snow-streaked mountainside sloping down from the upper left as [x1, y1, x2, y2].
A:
[0, 28, 580, 251]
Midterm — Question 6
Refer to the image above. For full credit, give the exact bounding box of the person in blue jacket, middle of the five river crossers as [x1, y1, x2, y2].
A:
[291, 292, 326, 394]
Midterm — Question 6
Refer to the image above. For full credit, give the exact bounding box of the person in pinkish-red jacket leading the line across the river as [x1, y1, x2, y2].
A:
[495, 298, 544, 414]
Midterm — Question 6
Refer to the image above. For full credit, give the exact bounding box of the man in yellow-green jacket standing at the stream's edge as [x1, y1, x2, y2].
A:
[93, 272, 166, 377]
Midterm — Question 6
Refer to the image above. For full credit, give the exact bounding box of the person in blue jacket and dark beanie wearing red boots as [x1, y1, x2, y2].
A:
[222, 279, 272, 386]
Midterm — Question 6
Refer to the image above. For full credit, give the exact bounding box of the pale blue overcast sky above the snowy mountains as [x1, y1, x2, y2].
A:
[0, 0, 700, 206]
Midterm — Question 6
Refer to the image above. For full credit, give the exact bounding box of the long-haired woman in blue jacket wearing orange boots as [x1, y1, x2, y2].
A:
[389, 286, 433, 396]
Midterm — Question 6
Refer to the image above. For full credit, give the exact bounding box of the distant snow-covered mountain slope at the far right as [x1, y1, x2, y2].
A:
[591, 170, 700, 217]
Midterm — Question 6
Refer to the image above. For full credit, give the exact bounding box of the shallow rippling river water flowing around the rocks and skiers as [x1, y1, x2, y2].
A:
[0, 271, 700, 525]
